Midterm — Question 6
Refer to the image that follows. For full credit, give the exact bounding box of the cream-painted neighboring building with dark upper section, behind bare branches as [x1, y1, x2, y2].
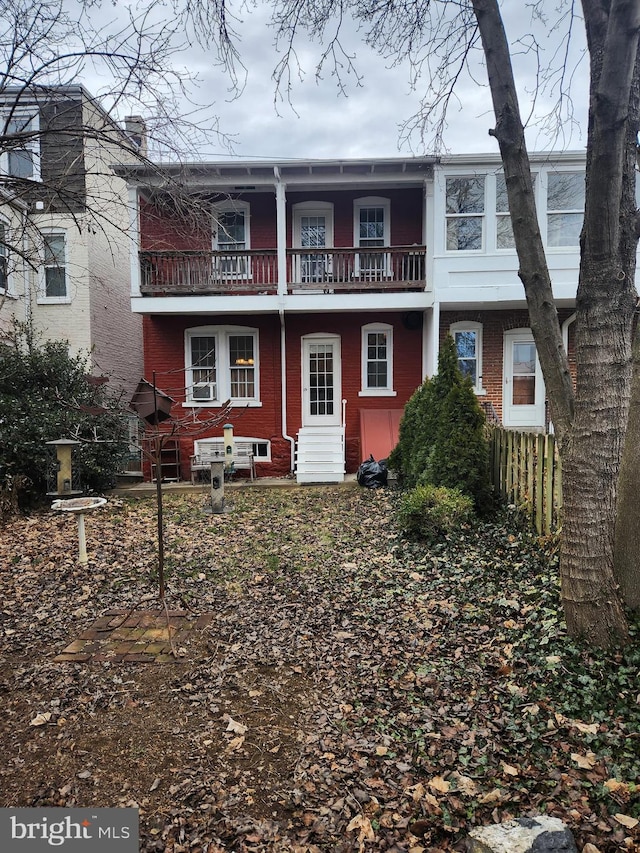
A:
[0, 86, 142, 396]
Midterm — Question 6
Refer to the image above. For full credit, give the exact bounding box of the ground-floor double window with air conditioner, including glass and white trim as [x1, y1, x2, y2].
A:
[185, 326, 260, 406]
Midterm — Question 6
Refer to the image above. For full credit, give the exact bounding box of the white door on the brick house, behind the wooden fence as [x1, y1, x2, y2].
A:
[502, 329, 545, 428]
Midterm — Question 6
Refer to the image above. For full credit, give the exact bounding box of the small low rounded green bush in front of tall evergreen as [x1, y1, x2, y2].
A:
[398, 484, 474, 543]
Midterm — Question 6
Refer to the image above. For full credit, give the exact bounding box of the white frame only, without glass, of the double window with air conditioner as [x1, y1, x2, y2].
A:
[182, 326, 262, 409]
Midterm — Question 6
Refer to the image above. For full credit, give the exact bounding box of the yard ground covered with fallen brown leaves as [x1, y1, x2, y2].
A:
[0, 487, 640, 853]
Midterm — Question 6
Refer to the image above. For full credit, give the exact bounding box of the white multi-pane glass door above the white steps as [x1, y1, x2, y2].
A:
[302, 335, 342, 427]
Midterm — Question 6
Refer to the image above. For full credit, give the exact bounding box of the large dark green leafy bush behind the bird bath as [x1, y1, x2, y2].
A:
[0, 323, 128, 509]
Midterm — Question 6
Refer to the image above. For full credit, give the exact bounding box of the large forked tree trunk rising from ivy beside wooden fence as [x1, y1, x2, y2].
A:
[472, 0, 639, 646]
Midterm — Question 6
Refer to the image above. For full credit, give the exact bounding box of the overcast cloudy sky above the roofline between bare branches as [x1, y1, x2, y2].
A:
[81, 0, 588, 161]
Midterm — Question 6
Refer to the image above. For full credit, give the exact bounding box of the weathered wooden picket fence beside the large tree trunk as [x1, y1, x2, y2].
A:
[490, 427, 562, 536]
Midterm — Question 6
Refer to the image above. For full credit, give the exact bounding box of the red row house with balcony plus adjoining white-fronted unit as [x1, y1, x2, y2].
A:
[116, 153, 584, 482]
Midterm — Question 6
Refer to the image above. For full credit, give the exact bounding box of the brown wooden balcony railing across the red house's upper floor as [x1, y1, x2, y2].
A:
[140, 246, 426, 295]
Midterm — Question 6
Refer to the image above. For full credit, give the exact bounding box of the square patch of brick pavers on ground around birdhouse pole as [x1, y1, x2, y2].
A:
[54, 609, 213, 663]
